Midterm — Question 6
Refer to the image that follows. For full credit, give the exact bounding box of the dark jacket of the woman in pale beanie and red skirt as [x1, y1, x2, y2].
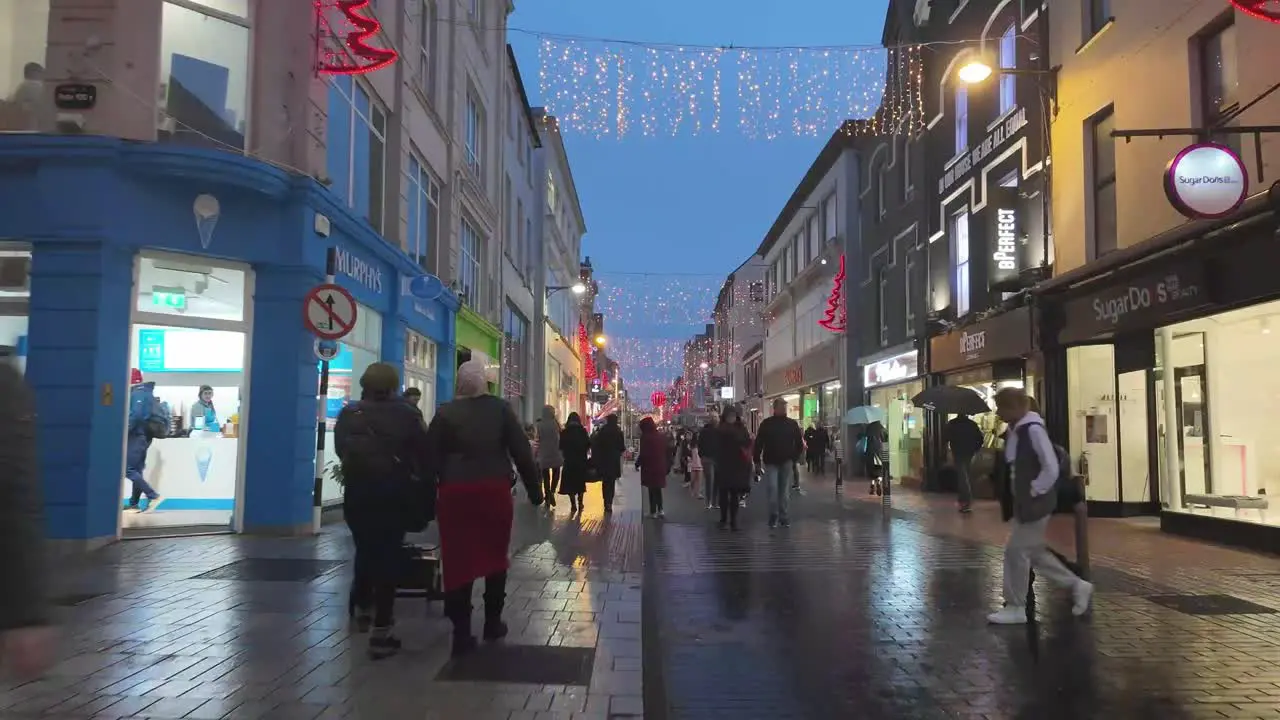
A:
[428, 395, 535, 503]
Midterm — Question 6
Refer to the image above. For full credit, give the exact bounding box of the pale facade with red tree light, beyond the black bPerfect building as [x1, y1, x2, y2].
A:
[756, 126, 861, 434]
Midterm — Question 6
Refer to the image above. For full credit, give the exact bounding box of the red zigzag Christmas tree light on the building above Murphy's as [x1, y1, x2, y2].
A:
[315, 0, 399, 76]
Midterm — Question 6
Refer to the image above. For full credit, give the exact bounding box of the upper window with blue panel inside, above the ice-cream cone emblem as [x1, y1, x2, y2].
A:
[157, 0, 250, 151]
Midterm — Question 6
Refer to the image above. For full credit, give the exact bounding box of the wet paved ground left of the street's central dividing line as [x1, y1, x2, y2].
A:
[0, 480, 644, 720]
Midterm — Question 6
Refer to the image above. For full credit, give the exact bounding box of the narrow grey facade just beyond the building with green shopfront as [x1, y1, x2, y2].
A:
[502, 45, 544, 423]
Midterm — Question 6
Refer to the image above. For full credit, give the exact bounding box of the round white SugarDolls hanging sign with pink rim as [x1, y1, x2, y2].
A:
[1165, 142, 1249, 220]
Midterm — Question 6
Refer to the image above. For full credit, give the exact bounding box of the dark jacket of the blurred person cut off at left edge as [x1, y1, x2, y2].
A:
[0, 363, 49, 630]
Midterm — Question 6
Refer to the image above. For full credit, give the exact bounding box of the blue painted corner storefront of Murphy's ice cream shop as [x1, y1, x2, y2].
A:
[0, 135, 457, 541]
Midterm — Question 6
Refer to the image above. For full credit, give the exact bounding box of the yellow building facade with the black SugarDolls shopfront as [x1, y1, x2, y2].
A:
[1037, 0, 1280, 551]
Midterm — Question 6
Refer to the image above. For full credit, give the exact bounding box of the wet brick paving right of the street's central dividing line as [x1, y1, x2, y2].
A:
[645, 468, 1280, 720]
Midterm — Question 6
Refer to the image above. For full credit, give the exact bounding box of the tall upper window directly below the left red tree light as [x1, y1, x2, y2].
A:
[325, 76, 387, 233]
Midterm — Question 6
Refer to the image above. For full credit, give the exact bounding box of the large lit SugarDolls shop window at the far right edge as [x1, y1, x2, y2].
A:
[1153, 302, 1280, 524]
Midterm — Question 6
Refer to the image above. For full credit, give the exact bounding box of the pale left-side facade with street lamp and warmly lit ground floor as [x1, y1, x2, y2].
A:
[534, 108, 588, 420]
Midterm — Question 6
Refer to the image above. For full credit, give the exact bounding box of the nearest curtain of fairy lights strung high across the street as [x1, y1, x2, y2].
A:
[539, 37, 924, 140]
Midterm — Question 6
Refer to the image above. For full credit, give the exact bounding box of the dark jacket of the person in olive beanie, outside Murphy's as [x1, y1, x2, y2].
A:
[333, 396, 435, 529]
